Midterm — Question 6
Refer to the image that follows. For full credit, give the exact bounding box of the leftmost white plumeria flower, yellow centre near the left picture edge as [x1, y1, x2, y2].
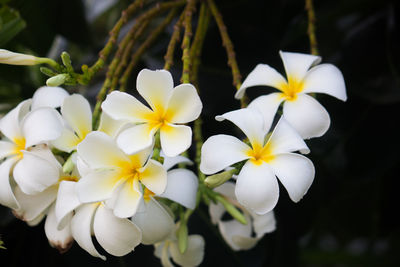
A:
[0, 92, 62, 209]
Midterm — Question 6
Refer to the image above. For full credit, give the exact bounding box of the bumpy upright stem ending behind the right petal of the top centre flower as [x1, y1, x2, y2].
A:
[181, 0, 196, 83]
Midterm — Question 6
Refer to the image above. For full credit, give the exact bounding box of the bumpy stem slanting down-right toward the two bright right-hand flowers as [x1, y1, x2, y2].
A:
[207, 0, 247, 107]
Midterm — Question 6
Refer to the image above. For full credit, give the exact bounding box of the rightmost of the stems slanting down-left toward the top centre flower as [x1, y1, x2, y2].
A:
[119, 7, 184, 91]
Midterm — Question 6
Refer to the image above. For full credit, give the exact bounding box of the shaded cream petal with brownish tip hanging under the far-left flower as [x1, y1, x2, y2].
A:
[14, 186, 57, 221]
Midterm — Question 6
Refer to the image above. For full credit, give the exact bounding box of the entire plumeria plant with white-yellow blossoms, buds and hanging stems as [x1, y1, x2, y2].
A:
[0, 0, 347, 266]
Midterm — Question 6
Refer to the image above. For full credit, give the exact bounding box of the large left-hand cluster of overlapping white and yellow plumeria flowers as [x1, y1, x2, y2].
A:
[0, 69, 204, 266]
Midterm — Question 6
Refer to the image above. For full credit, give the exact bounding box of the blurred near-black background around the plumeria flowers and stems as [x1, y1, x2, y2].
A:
[0, 0, 400, 267]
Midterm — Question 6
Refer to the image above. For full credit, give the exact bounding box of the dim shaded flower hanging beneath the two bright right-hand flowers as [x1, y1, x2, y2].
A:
[208, 182, 276, 250]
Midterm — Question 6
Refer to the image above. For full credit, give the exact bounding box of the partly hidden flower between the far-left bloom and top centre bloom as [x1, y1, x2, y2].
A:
[52, 94, 125, 153]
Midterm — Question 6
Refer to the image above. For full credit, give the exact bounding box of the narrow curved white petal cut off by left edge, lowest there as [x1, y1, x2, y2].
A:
[0, 157, 19, 209]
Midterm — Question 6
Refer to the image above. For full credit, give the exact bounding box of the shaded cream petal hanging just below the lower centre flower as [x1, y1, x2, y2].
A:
[132, 198, 175, 245]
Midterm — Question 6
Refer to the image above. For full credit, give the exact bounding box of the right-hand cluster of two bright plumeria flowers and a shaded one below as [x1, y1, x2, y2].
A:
[200, 52, 346, 249]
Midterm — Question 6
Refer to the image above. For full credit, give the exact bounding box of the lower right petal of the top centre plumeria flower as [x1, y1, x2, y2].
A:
[160, 124, 192, 157]
